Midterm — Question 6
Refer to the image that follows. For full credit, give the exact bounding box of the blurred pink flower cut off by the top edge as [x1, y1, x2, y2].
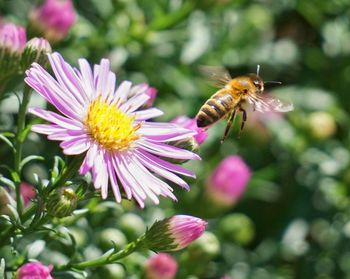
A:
[30, 0, 76, 42]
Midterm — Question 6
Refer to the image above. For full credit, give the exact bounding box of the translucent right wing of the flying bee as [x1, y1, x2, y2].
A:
[248, 95, 294, 112]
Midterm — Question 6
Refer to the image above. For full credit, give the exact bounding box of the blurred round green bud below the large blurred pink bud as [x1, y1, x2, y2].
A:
[218, 213, 255, 245]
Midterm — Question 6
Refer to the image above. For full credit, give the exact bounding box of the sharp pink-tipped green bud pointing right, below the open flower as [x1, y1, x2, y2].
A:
[145, 215, 207, 251]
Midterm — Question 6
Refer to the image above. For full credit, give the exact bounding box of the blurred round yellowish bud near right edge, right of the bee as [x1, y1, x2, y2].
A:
[308, 111, 337, 140]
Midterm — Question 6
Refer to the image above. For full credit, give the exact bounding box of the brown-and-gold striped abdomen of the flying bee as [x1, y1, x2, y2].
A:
[196, 89, 237, 128]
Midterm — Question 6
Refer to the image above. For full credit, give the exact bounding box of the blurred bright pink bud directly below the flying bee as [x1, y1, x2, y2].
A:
[206, 156, 251, 206]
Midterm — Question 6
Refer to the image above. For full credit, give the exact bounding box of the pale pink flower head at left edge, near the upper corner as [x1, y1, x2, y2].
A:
[0, 22, 27, 54]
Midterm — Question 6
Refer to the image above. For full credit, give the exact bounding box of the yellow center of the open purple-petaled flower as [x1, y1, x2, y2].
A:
[85, 98, 141, 150]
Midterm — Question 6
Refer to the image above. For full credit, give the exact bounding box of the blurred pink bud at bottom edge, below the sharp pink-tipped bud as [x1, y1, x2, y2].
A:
[145, 253, 177, 279]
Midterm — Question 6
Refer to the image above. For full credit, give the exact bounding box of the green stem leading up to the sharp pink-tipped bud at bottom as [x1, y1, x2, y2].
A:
[64, 235, 145, 270]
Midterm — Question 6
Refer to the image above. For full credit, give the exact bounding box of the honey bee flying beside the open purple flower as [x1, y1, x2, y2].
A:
[196, 65, 294, 143]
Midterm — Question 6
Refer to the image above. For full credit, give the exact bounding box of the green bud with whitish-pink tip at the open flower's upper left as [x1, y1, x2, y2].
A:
[21, 38, 52, 70]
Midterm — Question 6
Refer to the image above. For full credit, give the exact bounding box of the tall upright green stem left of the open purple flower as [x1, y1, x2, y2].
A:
[14, 85, 32, 219]
